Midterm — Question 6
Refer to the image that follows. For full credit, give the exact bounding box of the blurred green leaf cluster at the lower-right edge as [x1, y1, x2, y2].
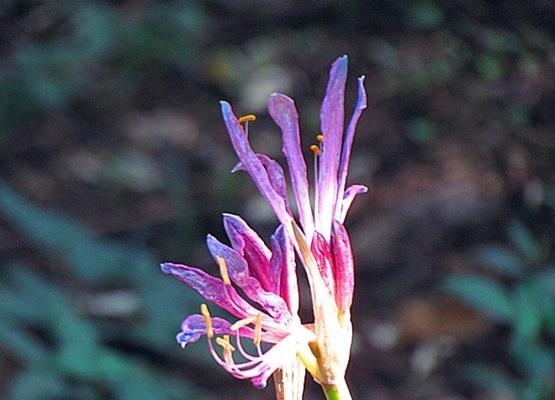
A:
[445, 221, 555, 400]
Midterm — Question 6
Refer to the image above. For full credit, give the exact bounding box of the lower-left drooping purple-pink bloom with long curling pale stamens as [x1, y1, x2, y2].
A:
[161, 214, 315, 388]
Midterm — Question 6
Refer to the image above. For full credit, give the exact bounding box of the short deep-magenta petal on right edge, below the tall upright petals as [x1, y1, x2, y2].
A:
[331, 221, 355, 312]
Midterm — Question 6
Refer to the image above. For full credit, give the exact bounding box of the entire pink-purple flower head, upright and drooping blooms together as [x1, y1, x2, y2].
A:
[162, 56, 367, 398]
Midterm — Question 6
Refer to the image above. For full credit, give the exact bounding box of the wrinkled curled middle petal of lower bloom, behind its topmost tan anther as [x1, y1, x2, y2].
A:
[206, 235, 291, 323]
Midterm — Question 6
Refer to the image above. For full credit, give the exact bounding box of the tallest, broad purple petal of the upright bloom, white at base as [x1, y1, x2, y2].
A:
[316, 56, 348, 239]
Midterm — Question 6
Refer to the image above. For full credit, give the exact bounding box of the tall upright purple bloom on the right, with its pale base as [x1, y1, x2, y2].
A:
[221, 56, 367, 398]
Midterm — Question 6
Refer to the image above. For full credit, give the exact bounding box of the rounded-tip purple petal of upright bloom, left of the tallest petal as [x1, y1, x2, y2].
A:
[268, 93, 314, 238]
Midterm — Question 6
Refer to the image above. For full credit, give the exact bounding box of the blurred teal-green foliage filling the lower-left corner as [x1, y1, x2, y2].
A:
[0, 186, 206, 400]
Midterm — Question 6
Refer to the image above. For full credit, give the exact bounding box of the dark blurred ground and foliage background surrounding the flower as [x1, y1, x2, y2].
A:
[0, 0, 555, 400]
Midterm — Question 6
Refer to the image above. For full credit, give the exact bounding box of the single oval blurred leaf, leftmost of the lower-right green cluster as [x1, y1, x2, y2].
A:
[445, 275, 512, 321]
